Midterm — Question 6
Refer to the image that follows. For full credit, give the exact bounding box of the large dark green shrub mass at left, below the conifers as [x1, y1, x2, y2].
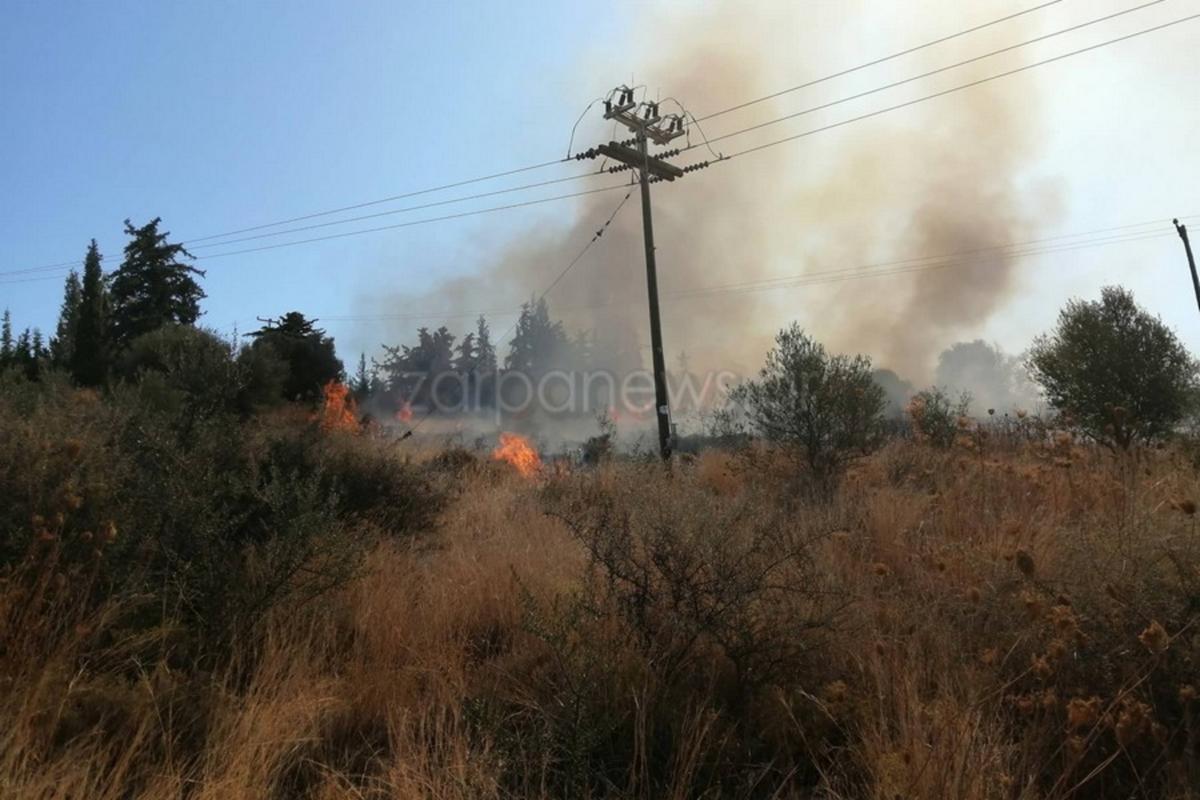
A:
[0, 373, 374, 644]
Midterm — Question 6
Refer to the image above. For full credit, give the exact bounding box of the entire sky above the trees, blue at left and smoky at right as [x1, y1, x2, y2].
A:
[0, 0, 1200, 381]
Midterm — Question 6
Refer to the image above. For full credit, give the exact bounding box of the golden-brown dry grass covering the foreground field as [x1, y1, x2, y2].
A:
[0, 437, 1200, 800]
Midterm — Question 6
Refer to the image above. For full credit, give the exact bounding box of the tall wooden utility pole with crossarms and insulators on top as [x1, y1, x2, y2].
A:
[575, 86, 708, 461]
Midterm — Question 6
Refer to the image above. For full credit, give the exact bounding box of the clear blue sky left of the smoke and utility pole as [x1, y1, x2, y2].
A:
[0, 0, 619, 350]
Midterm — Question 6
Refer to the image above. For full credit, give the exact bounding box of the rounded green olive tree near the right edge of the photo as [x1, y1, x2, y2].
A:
[1028, 287, 1196, 450]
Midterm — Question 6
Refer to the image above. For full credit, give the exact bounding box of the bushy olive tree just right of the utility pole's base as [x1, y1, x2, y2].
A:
[733, 323, 887, 486]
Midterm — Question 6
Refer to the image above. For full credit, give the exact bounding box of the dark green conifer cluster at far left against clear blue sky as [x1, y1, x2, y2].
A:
[0, 217, 343, 402]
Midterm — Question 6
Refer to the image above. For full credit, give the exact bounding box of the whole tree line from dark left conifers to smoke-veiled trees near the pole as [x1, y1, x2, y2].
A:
[7, 217, 628, 410]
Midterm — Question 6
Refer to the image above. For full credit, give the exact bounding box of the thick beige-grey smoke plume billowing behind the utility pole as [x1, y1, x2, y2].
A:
[352, 2, 1054, 395]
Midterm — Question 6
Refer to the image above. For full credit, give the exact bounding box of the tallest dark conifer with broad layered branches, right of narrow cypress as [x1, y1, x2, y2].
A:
[109, 217, 205, 347]
